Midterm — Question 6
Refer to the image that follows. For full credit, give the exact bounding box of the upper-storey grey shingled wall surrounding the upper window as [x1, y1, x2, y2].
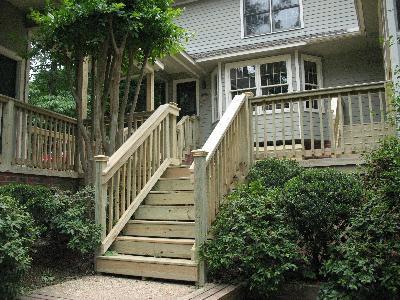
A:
[178, 0, 359, 57]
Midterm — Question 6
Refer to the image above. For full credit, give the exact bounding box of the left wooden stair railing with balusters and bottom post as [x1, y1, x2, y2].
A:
[95, 103, 179, 255]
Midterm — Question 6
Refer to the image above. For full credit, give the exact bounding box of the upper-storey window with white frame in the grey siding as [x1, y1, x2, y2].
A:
[242, 0, 301, 36]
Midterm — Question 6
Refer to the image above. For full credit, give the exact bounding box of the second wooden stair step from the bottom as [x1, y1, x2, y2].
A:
[112, 236, 194, 259]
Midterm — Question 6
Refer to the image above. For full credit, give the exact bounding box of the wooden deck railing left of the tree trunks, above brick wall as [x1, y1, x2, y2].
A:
[0, 96, 79, 177]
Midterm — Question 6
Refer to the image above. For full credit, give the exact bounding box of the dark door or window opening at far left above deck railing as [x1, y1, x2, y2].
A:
[0, 54, 17, 98]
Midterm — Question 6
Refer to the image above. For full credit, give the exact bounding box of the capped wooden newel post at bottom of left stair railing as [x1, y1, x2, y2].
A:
[94, 155, 109, 255]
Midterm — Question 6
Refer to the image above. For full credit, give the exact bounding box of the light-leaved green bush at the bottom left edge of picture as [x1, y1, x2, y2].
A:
[0, 196, 39, 299]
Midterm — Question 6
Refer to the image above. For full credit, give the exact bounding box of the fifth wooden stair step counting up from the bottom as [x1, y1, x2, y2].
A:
[145, 191, 194, 205]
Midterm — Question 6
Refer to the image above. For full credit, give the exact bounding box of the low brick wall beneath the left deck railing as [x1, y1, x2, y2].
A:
[0, 172, 79, 191]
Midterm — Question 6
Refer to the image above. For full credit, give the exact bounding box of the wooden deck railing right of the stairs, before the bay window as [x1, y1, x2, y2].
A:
[251, 83, 393, 159]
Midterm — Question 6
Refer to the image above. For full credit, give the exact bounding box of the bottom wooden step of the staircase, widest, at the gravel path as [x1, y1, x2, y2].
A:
[96, 255, 197, 282]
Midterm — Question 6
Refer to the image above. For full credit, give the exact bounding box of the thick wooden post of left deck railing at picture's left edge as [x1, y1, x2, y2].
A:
[1, 100, 18, 169]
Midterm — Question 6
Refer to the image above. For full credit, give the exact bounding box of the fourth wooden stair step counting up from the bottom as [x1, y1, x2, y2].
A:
[135, 205, 195, 221]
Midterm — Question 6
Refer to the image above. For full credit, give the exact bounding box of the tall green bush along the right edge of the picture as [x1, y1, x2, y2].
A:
[321, 138, 400, 299]
